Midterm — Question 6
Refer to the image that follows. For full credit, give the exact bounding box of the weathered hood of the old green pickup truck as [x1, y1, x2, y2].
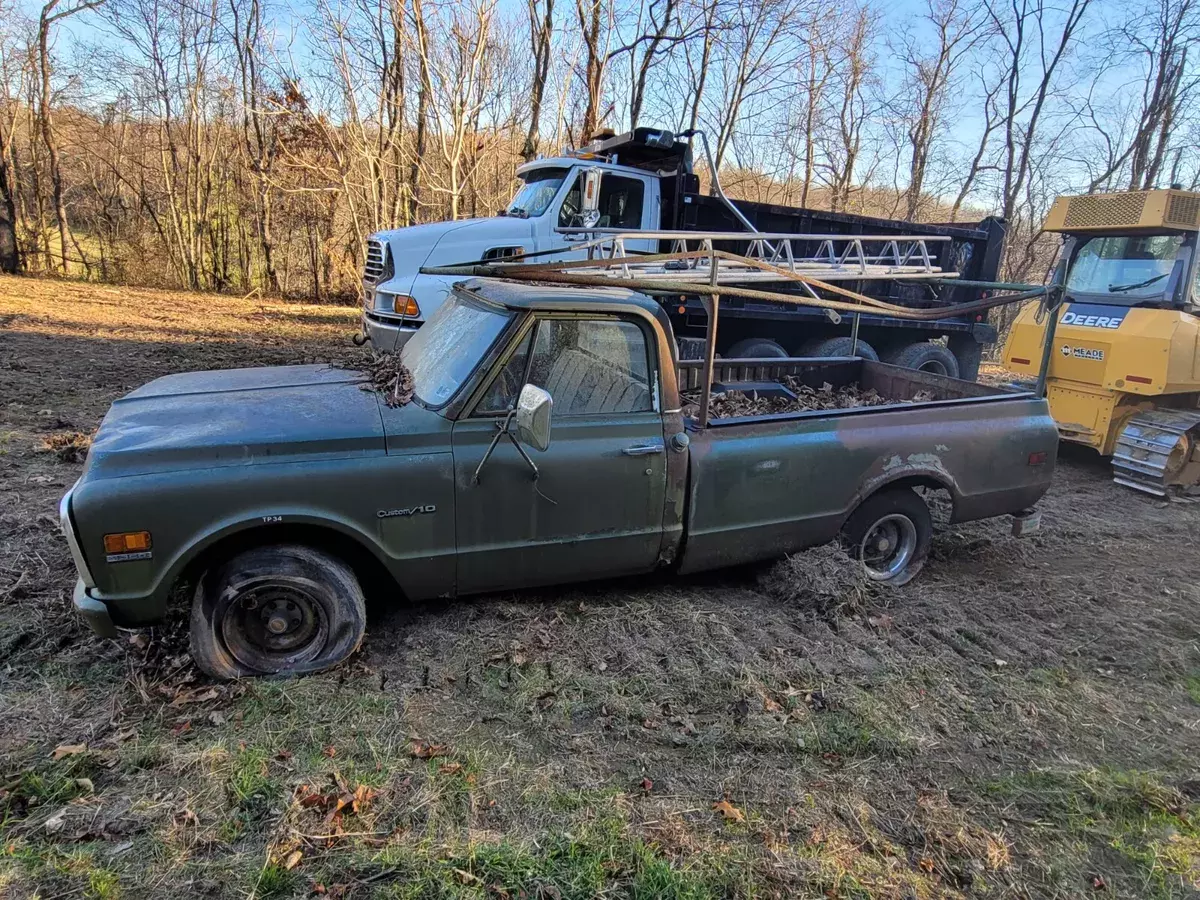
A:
[85, 366, 385, 478]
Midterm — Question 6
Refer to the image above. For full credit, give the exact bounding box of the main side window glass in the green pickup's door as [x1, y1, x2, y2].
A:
[529, 319, 654, 415]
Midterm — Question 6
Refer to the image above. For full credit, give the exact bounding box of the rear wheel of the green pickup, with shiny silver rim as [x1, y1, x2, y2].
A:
[841, 487, 934, 587]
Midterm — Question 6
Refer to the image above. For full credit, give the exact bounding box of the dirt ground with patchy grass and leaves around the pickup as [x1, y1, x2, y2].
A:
[0, 278, 1200, 900]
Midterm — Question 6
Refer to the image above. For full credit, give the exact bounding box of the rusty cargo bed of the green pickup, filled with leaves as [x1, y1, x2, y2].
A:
[679, 359, 1057, 571]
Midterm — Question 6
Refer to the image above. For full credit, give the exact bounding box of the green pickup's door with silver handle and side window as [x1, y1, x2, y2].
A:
[454, 316, 666, 593]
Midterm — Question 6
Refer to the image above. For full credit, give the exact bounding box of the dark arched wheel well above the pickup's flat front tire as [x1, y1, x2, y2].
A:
[173, 523, 401, 602]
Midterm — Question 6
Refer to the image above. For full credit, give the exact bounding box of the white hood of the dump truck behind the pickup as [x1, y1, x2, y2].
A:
[374, 216, 533, 290]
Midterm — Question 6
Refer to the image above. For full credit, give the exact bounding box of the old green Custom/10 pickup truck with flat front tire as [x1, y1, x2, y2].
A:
[60, 280, 1057, 678]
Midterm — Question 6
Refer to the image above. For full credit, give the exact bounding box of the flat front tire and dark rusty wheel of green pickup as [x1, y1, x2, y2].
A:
[191, 544, 367, 678]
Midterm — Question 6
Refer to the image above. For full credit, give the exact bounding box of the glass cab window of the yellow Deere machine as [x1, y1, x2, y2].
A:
[1067, 234, 1183, 304]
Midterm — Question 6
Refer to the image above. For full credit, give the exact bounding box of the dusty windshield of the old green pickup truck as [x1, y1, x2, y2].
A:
[401, 294, 512, 408]
